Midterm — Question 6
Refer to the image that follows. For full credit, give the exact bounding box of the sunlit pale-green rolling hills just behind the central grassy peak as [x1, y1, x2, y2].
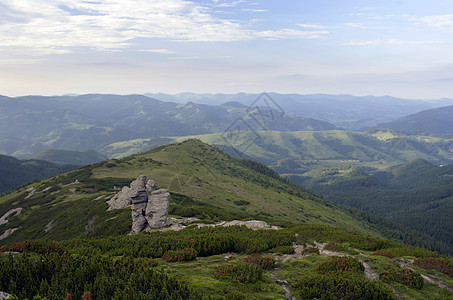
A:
[100, 130, 453, 168]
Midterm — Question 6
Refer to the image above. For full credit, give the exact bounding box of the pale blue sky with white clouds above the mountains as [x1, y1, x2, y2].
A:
[0, 0, 453, 99]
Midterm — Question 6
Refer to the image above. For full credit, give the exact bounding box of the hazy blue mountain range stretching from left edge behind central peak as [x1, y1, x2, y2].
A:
[0, 95, 336, 157]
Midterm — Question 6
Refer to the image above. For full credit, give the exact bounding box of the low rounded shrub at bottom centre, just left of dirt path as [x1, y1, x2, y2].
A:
[214, 262, 263, 283]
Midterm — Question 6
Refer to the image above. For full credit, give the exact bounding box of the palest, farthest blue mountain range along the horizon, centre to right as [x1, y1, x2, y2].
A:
[145, 93, 453, 130]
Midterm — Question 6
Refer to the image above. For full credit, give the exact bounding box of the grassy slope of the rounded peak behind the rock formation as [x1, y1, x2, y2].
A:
[0, 140, 369, 243]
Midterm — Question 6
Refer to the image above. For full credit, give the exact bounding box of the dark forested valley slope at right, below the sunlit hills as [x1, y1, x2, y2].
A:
[292, 159, 453, 252]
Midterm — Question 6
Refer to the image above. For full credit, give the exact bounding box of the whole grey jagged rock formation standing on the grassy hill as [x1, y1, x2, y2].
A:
[107, 175, 170, 234]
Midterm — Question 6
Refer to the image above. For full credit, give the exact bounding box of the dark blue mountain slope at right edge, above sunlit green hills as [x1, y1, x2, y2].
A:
[378, 105, 453, 135]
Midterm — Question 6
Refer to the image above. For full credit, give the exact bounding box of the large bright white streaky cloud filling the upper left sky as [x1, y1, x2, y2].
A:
[0, 0, 327, 55]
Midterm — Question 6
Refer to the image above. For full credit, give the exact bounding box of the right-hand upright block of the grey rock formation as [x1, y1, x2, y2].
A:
[145, 190, 170, 228]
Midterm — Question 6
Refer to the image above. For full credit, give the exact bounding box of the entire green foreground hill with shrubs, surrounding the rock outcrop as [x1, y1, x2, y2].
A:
[0, 140, 453, 300]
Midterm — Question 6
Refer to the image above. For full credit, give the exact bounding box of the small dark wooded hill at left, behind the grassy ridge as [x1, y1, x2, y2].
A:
[33, 149, 107, 166]
